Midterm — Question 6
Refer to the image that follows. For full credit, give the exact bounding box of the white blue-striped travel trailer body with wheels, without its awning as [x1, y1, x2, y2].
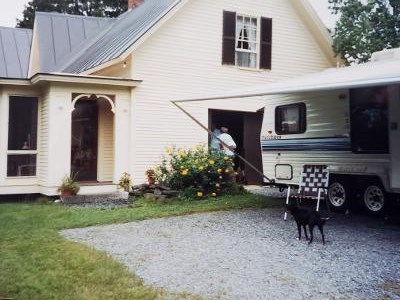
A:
[261, 81, 400, 214]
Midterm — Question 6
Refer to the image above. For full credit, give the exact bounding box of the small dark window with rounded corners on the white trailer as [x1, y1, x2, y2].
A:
[275, 103, 306, 134]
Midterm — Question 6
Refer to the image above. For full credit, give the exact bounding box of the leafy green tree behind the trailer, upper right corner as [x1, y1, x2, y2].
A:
[329, 0, 400, 64]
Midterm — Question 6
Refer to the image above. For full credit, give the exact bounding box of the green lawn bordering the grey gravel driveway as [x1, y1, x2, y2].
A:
[0, 194, 283, 300]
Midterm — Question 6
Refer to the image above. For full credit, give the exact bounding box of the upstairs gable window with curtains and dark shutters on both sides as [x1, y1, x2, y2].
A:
[222, 11, 272, 69]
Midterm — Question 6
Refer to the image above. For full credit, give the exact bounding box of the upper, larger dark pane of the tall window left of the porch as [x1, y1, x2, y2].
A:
[8, 97, 38, 150]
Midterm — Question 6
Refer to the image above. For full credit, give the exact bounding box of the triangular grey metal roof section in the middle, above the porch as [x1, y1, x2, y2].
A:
[34, 12, 116, 72]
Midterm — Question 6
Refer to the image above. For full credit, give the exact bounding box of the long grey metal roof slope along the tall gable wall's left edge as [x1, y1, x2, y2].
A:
[63, 0, 182, 73]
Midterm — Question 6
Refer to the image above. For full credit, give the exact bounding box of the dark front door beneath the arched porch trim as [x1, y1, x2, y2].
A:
[71, 100, 98, 181]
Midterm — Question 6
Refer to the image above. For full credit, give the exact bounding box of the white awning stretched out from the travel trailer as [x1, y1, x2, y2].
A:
[174, 59, 400, 102]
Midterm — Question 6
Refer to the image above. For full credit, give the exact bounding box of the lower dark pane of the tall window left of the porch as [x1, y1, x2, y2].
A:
[7, 154, 36, 177]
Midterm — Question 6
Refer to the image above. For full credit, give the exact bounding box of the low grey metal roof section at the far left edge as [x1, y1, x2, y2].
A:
[0, 27, 32, 78]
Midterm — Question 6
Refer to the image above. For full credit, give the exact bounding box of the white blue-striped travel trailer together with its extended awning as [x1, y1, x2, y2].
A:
[178, 49, 400, 214]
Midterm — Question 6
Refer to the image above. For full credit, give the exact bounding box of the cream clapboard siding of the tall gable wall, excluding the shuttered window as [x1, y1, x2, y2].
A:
[125, 0, 332, 182]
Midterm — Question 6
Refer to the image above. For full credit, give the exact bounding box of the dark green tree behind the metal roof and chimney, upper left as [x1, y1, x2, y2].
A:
[17, 0, 127, 28]
